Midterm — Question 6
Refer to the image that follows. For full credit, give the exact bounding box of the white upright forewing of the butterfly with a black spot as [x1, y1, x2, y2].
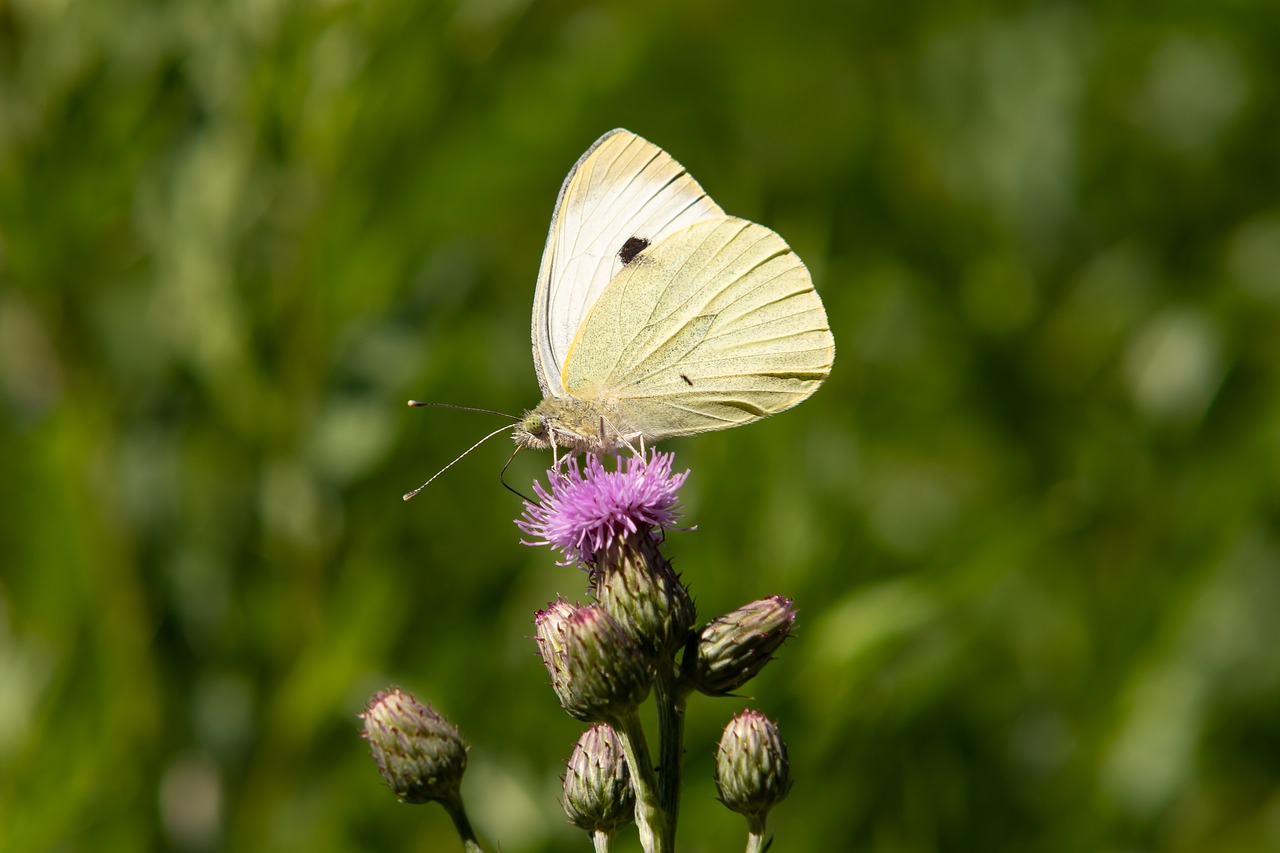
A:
[532, 129, 723, 397]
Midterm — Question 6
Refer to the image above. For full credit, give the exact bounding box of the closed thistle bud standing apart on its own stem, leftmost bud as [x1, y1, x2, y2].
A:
[360, 689, 467, 803]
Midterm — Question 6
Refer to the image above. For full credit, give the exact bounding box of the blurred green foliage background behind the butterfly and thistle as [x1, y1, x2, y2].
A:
[0, 0, 1280, 853]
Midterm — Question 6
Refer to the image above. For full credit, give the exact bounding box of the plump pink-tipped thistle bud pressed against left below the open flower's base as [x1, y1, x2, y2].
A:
[534, 601, 653, 722]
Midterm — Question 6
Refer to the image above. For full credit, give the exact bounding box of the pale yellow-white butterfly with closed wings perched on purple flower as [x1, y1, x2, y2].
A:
[513, 129, 836, 452]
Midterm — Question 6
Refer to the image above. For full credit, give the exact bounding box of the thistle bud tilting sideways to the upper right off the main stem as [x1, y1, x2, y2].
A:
[682, 596, 796, 695]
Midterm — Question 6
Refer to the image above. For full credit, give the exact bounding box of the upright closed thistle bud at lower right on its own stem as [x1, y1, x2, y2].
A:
[716, 710, 791, 824]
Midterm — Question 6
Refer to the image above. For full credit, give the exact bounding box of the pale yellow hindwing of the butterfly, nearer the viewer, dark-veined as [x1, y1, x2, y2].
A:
[561, 216, 836, 441]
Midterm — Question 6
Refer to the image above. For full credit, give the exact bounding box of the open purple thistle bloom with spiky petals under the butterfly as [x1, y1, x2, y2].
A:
[516, 451, 689, 566]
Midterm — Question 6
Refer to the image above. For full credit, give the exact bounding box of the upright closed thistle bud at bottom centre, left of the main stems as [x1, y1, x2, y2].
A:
[564, 722, 636, 834]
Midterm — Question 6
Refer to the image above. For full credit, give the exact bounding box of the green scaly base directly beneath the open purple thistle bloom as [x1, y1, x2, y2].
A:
[591, 535, 698, 662]
